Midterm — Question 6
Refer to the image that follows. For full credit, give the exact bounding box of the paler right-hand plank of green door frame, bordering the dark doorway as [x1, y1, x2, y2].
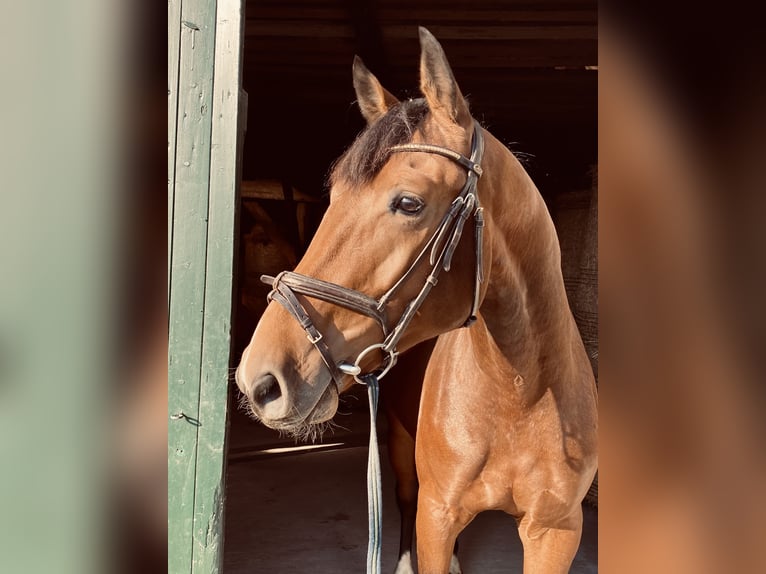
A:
[192, 0, 244, 574]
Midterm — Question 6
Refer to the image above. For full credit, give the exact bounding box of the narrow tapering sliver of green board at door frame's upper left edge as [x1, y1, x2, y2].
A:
[168, 0, 181, 301]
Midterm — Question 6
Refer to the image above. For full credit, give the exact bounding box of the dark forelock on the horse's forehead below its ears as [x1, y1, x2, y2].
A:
[329, 98, 428, 186]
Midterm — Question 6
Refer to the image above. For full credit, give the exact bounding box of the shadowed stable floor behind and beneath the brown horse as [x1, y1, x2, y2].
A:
[224, 392, 598, 574]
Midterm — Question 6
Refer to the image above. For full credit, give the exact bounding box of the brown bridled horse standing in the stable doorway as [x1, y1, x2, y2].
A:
[235, 28, 598, 574]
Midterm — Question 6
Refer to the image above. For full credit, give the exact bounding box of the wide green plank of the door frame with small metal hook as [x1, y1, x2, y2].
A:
[168, 0, 215, 573]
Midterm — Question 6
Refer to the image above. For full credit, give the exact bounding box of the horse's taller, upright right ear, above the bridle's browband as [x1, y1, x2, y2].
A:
[418, 26, 471, 128]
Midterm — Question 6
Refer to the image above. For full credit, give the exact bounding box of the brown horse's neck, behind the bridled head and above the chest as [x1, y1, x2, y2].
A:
[478, 140, 573, 382]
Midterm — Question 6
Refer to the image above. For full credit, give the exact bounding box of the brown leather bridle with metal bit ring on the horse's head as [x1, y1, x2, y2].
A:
[261, 122, 484, 388]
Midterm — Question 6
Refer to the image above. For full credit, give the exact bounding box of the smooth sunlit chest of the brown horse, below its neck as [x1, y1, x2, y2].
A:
[418, 331, 586, 480]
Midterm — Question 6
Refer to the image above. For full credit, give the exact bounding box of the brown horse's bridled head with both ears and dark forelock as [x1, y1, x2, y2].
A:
[236, 28, 483, 431]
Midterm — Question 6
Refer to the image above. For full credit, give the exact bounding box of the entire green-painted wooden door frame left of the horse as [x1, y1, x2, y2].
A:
[168, 0, 244, 574]
